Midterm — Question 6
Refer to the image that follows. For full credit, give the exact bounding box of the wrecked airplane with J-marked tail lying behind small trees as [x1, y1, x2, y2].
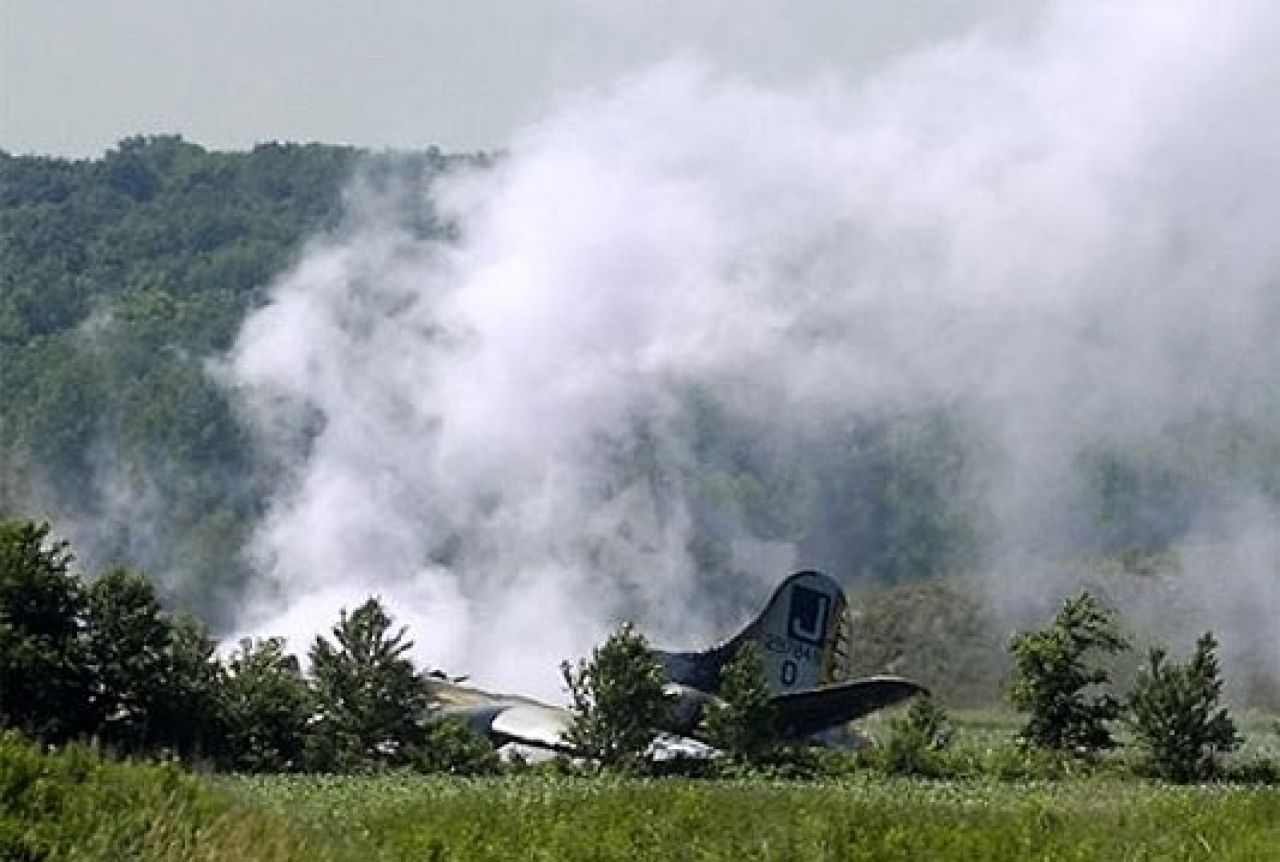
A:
[428, 571, 925, 753]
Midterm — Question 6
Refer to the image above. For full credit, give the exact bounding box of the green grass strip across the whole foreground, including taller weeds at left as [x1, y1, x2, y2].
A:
[0, 713, 1280, 862]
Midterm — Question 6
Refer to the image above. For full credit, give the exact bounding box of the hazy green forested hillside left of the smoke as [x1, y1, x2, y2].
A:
[0, 137, 458, 624]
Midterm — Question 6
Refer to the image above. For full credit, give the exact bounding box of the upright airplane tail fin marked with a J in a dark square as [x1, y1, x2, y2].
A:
[658, 571, 852, 695]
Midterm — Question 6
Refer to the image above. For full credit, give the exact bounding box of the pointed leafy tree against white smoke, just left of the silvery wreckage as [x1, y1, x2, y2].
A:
[310, 598, 429, 771]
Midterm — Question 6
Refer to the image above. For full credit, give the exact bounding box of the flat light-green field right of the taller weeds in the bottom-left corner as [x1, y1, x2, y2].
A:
[229, 776, 1280, 861]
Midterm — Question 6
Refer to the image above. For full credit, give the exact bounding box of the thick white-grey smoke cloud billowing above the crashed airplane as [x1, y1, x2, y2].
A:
[227, 0, 1280, 694]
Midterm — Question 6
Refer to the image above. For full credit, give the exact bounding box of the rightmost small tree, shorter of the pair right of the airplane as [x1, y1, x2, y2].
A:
[1129, 631, 1240, 783]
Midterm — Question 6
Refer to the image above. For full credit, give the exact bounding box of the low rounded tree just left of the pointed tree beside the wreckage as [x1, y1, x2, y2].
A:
[219, 638, 315, 772]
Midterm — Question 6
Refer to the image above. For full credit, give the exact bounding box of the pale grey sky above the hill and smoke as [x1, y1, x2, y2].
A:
[0, 0, 1024, 156]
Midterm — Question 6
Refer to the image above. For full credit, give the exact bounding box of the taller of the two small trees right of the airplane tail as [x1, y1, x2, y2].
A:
[1011, 592, 1128, 754]
